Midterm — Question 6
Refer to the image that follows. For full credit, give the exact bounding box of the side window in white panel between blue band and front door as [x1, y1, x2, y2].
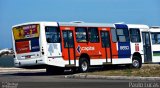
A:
[130, 28, 141, 42]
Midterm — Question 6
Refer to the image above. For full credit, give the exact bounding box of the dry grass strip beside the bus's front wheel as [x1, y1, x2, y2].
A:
[82, 64, 160, 77]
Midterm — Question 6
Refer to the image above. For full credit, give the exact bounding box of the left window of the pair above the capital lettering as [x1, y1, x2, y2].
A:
[76, 27, 87, 42]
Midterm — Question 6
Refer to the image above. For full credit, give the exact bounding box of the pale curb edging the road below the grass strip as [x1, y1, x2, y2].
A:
[65, 74, 160, 81]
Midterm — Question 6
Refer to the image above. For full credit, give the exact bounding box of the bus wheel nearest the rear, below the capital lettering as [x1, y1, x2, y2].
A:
[79, 57, 89, 72]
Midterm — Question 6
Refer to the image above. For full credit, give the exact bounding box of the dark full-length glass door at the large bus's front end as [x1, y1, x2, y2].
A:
[142, 32, 152, 62]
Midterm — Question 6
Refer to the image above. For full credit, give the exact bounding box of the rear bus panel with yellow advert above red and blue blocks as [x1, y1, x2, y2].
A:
[13, 24, 40, 54]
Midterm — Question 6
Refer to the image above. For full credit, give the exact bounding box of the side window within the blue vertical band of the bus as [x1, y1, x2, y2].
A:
[117, 29, 129, 42]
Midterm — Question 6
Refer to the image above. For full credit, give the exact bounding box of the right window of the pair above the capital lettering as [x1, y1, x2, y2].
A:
[88, 27, 99, 43]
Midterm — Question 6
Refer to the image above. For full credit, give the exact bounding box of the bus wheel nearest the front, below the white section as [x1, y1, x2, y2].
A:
[132, 56, 142, 68]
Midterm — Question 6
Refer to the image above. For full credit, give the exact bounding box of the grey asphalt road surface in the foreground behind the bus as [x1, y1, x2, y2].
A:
[0, 68, 160, 88]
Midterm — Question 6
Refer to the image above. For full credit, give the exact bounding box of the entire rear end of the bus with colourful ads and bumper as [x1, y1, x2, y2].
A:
[12, 24, 44, 67]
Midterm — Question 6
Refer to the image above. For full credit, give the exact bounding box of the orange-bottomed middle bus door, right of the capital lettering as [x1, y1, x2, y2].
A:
[100, 30, 112, 63]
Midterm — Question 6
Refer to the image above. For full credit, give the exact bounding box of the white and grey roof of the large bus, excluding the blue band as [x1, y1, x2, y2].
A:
[12, 21, 153, 29]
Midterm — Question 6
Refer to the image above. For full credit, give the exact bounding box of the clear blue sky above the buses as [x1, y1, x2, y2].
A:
[0, 0, 160, 49]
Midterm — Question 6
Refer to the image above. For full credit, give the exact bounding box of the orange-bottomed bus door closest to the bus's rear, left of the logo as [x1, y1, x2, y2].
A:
[62, 30, 76, 65]
